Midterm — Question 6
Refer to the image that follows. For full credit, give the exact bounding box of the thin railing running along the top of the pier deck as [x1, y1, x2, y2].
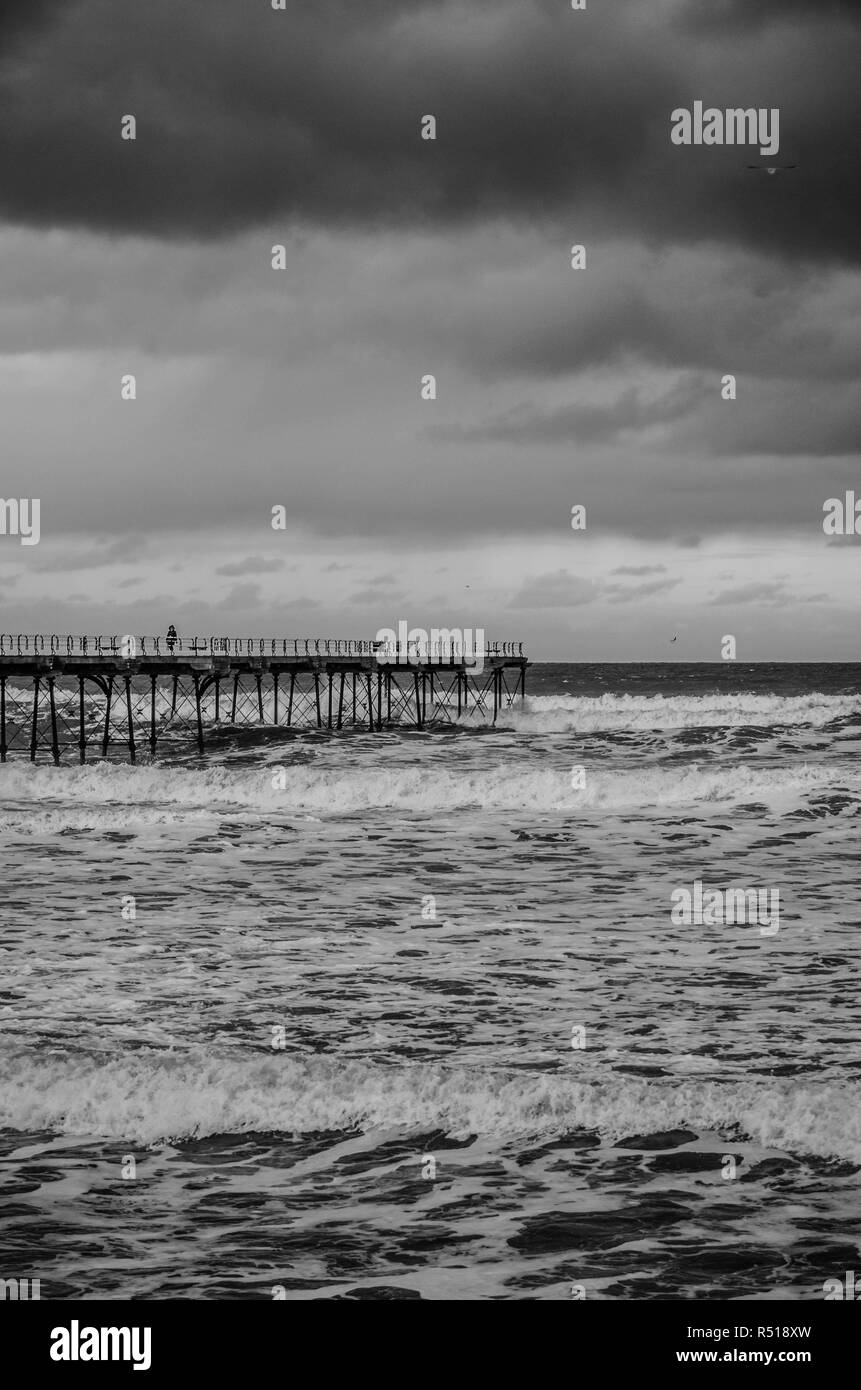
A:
[0, 632, 523, 660]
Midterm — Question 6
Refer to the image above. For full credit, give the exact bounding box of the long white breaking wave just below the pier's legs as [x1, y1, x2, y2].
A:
[0, 758, 861, 834]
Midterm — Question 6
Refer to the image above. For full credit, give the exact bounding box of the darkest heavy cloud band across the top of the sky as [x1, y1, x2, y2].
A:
[0, 0, 861, 261]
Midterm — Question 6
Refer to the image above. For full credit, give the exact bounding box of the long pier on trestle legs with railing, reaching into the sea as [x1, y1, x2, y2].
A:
[0, 634, 529, 765]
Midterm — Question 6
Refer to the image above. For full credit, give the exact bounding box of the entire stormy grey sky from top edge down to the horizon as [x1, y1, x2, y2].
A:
[0, 0, 861, 660]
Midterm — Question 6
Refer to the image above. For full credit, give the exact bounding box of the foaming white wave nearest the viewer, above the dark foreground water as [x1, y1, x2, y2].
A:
[0, 1048, 861, 1162]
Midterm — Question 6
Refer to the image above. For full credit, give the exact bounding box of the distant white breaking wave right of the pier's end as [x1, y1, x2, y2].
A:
[501, 694, 861, 734]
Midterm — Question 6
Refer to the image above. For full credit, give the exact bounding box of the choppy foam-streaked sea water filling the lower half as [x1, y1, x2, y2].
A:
[0, 666, 861, 1298]
